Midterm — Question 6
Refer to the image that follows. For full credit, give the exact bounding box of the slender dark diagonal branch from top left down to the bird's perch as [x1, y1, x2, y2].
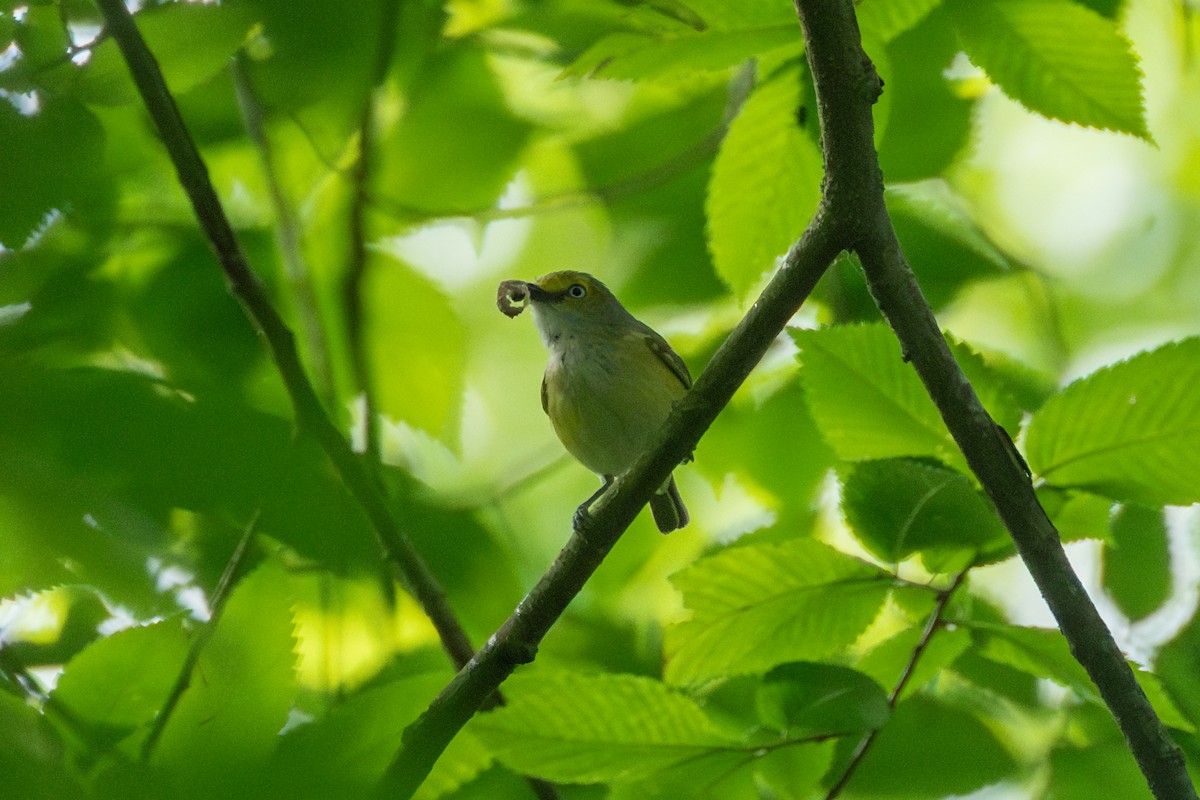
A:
[97, 0, 473, 666]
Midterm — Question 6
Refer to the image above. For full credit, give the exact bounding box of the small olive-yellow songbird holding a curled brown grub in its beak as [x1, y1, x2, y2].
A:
[497, 271, 691, 534]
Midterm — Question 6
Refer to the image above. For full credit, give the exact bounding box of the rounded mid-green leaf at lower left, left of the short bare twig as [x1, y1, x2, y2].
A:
[53, 621, 187, 738]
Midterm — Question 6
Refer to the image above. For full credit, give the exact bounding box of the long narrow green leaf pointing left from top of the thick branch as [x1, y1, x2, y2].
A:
[563, 20, 803, 80]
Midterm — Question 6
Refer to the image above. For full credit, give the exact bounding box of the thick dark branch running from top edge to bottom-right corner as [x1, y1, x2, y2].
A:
[796, 0, 1196, 800]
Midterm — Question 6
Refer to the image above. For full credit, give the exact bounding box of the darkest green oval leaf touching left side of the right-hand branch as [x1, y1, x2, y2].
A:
[841, 459, 1008, 569]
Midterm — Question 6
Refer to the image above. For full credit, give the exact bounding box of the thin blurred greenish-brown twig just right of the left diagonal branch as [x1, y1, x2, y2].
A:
[229, 52, 337, 410]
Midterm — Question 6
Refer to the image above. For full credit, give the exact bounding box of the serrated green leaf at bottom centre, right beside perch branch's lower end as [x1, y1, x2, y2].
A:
[473, 673, 738, 783]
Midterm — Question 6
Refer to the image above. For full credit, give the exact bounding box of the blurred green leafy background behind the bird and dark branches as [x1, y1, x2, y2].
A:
[0, 0, 1200, 800]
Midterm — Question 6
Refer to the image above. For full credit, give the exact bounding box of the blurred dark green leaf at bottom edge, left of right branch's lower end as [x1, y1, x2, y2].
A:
[1045, 742, 1152, 800]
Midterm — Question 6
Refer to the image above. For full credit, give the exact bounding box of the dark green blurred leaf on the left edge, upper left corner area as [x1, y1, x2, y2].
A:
[0, 96, 104, 249]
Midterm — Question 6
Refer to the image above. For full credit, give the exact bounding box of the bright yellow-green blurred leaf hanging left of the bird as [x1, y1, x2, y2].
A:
[364, 259, 467, 444]
